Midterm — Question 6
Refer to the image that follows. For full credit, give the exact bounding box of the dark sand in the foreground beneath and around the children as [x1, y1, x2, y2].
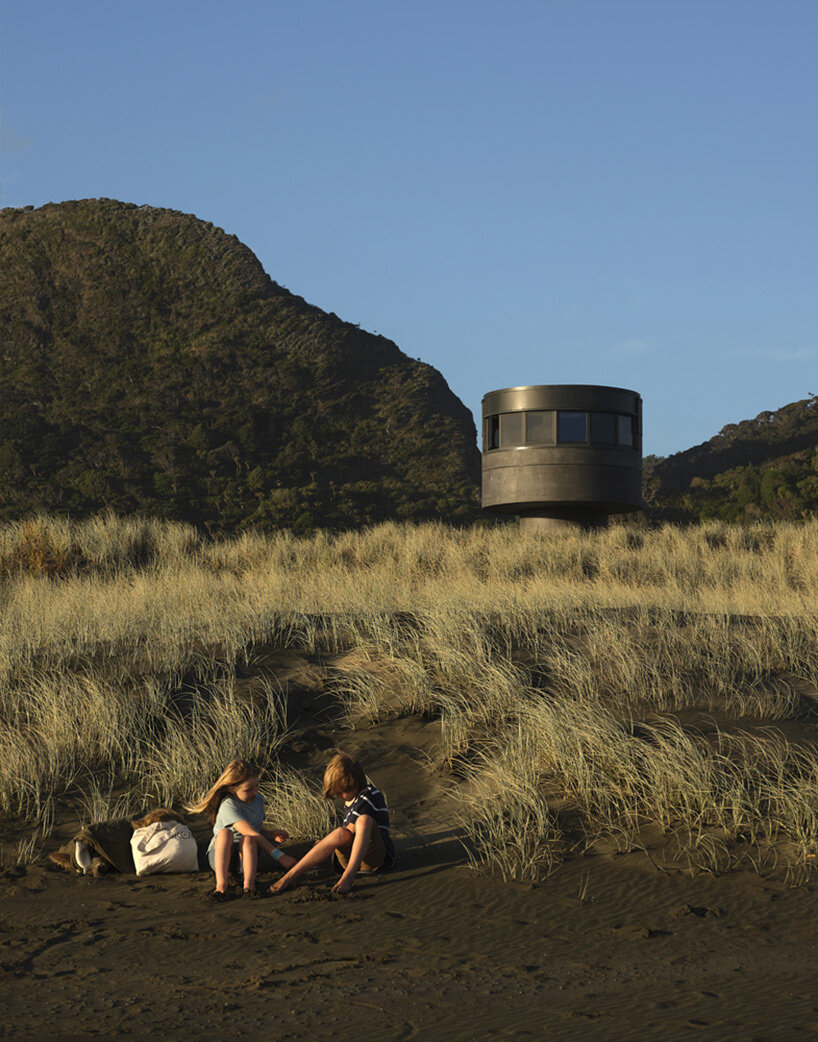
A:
[0, 675, 818, 1042]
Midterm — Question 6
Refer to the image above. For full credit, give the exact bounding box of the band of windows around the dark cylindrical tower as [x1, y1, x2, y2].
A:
[482, 410, 637, 452]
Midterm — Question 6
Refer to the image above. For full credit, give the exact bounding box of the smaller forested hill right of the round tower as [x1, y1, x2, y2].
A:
[645, 395, 818, 521]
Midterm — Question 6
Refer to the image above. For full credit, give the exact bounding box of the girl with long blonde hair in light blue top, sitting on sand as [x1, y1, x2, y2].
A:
[188, 760, 296, 901]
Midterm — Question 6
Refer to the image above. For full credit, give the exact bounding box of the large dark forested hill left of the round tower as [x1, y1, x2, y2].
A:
[0, 199, 479, 531]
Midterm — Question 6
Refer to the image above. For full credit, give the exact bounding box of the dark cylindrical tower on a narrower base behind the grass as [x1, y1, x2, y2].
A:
[482, 383, 642, 528]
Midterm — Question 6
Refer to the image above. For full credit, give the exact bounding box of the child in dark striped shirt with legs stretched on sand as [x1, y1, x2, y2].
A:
[270, 752, 395, 894]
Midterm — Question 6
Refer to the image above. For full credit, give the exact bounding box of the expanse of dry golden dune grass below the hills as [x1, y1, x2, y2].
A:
[0, 517, 818, 878]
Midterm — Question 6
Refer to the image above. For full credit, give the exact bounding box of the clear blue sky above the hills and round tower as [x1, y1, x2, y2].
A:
[0, 0, 818, 455]
